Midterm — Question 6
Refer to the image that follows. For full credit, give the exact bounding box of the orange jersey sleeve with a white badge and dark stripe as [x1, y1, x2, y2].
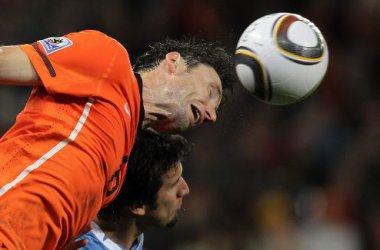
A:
[21, 30, 131, 97]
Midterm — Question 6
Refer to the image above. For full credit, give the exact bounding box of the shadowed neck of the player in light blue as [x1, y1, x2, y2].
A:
[97, 218, 142, 249]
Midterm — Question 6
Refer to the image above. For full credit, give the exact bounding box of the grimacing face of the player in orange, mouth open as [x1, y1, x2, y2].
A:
[146, 59, 222, 132]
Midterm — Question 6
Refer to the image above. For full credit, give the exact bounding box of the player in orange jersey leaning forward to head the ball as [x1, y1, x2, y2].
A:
[0, 30, 234, 249]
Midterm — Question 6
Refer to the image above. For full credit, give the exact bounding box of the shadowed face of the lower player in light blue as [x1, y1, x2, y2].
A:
[145, 162, 190, 227]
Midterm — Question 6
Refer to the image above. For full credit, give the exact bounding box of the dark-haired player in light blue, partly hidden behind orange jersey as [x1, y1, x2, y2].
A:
[77, 130, 191, 250]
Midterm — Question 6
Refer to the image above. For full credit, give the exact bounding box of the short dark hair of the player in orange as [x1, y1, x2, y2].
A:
[134, 36, 236, 104]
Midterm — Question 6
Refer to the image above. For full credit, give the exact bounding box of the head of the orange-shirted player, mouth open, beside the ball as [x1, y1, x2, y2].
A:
[135, 37, 236, 132]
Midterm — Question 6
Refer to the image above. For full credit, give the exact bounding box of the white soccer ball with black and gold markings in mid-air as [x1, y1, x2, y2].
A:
[234, 13, 329, 105]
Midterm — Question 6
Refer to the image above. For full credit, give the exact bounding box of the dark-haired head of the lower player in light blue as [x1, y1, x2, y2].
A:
[99, 130, 191, 228]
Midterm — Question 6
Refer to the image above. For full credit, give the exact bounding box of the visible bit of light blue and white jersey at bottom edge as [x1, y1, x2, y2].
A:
[77, 222, 144, 250]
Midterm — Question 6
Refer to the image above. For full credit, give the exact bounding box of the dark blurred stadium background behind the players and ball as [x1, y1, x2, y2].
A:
[0, 0, 380, 250]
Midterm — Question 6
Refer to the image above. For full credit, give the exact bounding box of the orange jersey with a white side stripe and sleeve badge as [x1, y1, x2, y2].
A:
[0, 31, 143, 249]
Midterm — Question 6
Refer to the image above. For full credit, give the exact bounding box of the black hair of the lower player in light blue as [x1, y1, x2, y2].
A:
[99, 129, 191, 221]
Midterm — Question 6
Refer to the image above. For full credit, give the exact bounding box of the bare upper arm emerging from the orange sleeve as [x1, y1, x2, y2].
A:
[0, 46, 40, 85]
